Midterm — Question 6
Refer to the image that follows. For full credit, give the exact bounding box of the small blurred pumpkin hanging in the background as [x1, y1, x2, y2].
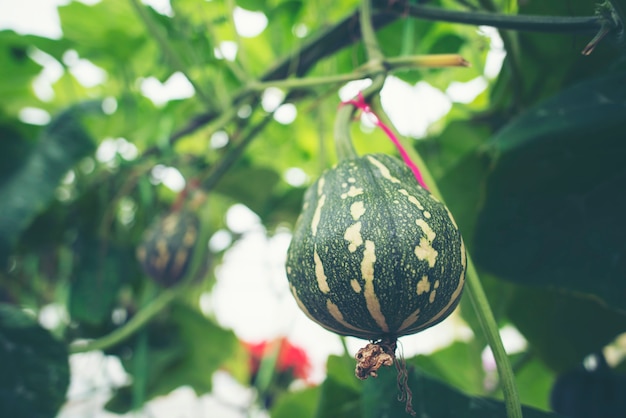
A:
[137, 210, 200, 287]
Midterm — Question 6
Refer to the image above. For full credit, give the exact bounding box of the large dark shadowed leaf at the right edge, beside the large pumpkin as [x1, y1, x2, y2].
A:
[474, 73, 626, 310]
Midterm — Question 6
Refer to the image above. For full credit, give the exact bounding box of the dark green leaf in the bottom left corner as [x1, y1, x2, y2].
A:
[0, 304, 70, 418]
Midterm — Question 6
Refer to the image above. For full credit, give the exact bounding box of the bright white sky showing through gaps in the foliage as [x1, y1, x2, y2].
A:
[0, 0, 503, 418]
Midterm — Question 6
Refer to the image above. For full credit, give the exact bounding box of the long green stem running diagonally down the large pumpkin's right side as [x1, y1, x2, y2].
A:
[372, 97, 522, 418]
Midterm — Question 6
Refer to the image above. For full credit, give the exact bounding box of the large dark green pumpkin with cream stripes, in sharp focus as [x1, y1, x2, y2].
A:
[286, 154, 466, 340]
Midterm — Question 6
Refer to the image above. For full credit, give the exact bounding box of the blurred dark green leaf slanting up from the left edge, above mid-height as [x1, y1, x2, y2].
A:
[0, 102, 100, 259]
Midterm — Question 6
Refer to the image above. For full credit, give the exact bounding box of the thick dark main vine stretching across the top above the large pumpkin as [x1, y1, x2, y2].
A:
[139, 0, 623, 155]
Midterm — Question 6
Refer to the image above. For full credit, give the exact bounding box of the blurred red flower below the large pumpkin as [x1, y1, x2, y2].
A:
[244, 337, 311, 380]
